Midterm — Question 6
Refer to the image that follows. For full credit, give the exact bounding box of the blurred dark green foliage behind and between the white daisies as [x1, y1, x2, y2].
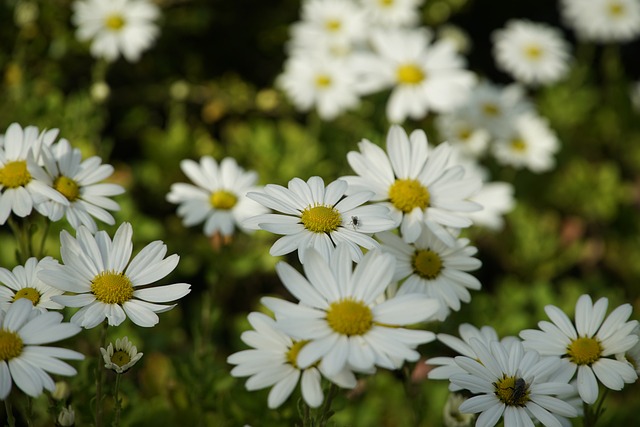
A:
[0, 0, 640, 427]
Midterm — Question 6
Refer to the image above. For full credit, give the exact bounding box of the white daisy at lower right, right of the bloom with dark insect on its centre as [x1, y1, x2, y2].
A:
[520, 295, 638, 404]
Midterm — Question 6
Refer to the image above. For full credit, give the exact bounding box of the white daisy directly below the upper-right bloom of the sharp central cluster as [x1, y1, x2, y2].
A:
[376, 227, 482, 320]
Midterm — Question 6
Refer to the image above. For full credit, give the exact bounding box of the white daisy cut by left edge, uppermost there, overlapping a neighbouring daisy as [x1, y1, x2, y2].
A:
[0, 123, 69, 225]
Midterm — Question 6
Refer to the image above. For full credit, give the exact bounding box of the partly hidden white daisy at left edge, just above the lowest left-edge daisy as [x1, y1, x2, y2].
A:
[0, 257, 63, 311]
